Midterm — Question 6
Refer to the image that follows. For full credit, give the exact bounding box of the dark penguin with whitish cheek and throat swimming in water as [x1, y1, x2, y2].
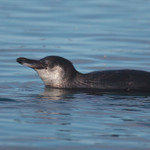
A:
[17, 56, 150, 92]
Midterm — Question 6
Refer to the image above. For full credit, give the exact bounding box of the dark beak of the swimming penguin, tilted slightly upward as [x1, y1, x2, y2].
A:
[16, 57, 46, 69]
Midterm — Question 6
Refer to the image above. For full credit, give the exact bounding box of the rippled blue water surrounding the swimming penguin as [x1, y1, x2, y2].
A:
[0, 0, 150, 150]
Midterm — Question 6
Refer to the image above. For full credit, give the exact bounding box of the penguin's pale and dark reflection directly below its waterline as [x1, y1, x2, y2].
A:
[40, 87, 150, 101]
